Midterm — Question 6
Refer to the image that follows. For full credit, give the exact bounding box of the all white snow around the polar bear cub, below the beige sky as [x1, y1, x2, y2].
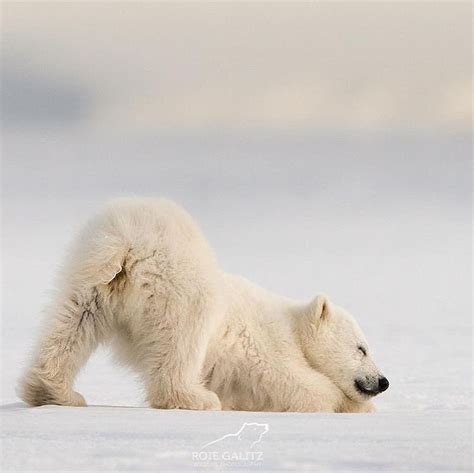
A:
[1, 133, 472, 472]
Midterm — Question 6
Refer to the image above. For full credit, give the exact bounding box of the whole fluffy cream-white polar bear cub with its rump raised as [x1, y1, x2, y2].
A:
[20, 198, 388, 412]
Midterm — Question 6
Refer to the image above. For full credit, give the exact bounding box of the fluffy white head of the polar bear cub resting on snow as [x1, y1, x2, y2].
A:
[301, 296, 389, 402]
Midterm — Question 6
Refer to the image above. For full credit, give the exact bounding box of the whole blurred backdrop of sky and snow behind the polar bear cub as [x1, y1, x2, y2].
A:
[1, 2, 472, 412]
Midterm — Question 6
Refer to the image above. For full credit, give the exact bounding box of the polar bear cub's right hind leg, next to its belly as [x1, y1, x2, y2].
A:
[135, 284, 221, 410]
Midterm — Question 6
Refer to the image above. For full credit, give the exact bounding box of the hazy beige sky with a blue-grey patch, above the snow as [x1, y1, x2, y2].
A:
[2, 2, 472, 133]
